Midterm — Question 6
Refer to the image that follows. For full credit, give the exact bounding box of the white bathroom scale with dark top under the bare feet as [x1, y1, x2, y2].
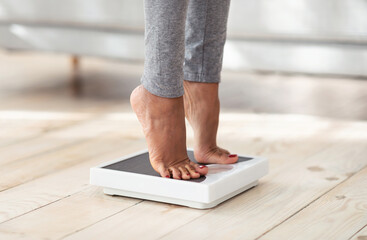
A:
[90, 149, 268, 209]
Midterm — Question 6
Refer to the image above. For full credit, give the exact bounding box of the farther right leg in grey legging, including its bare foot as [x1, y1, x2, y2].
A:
[184, 0, 238, 163]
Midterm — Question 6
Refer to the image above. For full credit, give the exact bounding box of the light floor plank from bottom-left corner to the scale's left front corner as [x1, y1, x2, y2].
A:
[0, 187, 140, 239]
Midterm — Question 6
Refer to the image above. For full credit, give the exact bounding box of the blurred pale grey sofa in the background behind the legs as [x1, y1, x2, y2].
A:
[0, 0, 367, 76]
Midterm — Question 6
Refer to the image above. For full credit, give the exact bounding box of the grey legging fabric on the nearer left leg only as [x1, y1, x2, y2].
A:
[141, 0, 189, 98]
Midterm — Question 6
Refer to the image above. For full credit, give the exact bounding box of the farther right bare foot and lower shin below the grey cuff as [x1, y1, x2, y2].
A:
[184, 80, 238, 164]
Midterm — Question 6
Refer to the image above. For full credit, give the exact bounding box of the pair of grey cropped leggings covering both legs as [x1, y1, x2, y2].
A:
[141, 0, 230, 98]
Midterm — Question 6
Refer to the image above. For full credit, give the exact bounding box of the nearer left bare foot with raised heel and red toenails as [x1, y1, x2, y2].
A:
[130, 85, 208, 179]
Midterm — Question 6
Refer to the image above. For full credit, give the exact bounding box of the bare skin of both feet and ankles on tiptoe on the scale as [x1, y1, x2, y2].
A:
[130, 81, 238, 180]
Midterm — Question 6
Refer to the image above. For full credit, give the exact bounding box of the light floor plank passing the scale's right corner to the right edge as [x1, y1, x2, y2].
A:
[159, 124, 367, 239]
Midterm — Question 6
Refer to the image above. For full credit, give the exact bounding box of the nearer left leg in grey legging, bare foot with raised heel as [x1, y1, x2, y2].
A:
[130, 0, 208, 179]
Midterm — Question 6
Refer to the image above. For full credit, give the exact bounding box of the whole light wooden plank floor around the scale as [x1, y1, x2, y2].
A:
[0, 49, 367, 240]
